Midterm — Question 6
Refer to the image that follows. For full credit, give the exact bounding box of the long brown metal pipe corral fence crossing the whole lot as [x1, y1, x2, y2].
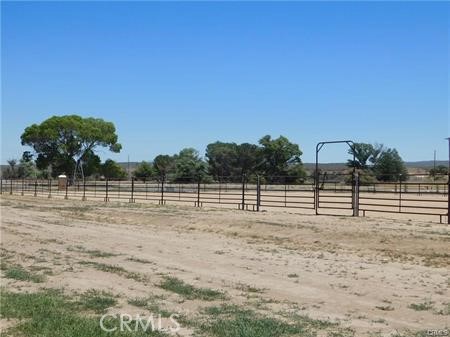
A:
[0, 173, 450, 223]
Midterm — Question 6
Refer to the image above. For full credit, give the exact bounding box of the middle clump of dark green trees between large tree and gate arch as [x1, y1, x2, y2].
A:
[134, 135, 307, 182]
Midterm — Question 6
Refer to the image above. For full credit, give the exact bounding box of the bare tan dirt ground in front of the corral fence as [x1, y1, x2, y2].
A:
[1, 195, 450, 336]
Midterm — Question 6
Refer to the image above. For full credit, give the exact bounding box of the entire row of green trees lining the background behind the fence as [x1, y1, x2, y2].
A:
[3, 115, 432, 182]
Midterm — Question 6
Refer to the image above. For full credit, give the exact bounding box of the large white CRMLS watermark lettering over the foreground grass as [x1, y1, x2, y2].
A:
[100, 314, 180, 333]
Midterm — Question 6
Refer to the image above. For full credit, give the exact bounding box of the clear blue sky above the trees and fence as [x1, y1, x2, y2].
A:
[1, 2, 450, 163]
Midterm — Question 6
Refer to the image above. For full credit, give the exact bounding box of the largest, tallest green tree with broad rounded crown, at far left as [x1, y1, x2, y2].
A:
[21, 115, 122, 176]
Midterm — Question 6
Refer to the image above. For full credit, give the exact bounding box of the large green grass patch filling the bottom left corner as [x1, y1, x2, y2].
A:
[0, 290, 168, 337]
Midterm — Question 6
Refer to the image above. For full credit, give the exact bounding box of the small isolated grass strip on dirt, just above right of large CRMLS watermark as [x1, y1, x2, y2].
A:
[159, 276, 225, 301]
